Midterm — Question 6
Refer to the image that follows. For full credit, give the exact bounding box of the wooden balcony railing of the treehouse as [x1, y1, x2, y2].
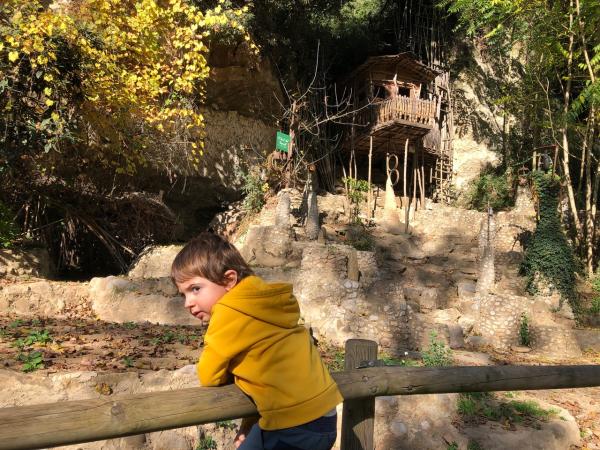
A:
[356, 97, 437, 127]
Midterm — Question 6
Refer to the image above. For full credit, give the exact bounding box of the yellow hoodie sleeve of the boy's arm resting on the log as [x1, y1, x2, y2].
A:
[196, 304, 249, 386]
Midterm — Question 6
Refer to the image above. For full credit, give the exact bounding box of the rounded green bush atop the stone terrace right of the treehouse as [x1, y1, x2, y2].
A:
[467, 170, 514, 211]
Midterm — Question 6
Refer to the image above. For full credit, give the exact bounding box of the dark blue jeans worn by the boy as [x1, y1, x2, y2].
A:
[238, 415, 337, 450]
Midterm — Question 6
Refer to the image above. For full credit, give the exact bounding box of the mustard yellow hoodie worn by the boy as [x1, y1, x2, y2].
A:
[197, 276, 343, 430]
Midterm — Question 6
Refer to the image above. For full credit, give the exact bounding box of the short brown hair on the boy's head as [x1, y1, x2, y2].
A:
[171, 232, 254, 285]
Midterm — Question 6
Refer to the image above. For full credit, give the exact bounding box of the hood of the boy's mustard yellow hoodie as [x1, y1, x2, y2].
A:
[217, 275, 300, 328]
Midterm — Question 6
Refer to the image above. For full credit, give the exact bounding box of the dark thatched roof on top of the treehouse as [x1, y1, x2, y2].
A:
[346, 52, 441, 83]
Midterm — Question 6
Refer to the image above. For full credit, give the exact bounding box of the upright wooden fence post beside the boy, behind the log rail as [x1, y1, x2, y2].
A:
[341, 339, 377, 450]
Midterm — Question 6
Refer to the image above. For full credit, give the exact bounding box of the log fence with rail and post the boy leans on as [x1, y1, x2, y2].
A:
[0, 339, 600, 450]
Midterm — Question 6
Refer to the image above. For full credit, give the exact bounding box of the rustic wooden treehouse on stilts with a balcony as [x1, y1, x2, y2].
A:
[343, 52, 452, 202]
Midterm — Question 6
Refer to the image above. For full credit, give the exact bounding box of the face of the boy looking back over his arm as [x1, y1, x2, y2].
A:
[177, 270, 237, 322]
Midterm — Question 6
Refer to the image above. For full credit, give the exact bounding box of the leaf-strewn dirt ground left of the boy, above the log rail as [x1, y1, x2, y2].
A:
[0, 315, 205, 373]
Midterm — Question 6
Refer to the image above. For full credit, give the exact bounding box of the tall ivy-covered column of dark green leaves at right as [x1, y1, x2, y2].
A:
[520, 171, 578, 311]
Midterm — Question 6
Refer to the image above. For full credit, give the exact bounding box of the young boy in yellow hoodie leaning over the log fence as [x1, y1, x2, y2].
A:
[171, 233, 343, 450]
